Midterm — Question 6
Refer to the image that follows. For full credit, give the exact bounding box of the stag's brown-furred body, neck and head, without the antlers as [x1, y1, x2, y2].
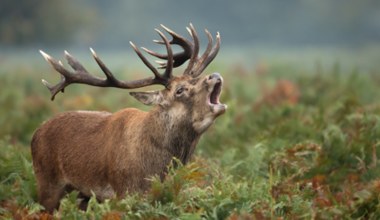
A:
[31, 75, 225, 212]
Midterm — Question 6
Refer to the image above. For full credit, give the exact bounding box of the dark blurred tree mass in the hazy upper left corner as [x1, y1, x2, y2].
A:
[0, 0, 96, 46]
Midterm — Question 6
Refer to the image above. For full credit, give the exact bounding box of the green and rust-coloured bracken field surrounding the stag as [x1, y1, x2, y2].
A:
[0, 54, 380, 220]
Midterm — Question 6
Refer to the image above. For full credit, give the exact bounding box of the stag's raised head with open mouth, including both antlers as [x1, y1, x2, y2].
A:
[41, 24, 227, 133]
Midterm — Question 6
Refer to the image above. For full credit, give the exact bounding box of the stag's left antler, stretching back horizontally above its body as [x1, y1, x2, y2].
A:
[40, 29, 173, 100]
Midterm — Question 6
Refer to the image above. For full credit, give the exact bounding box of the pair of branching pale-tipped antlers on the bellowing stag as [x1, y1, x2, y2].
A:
[40, 23, 220, 100]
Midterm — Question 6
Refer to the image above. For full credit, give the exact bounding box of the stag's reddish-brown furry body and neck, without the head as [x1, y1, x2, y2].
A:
[32, 107, 199, 210]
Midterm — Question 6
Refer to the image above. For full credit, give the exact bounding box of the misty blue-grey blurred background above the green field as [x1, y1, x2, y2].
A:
[0, 0, 380, 70]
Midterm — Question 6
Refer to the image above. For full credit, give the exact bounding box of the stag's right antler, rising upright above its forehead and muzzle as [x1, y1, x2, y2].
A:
[142, 23, 221, 77]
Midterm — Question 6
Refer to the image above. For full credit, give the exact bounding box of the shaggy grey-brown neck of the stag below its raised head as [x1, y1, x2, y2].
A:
[145, 106, 200, 164]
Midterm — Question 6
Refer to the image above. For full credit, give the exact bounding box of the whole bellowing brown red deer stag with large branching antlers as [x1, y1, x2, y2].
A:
[31, 24, 227, 212]
